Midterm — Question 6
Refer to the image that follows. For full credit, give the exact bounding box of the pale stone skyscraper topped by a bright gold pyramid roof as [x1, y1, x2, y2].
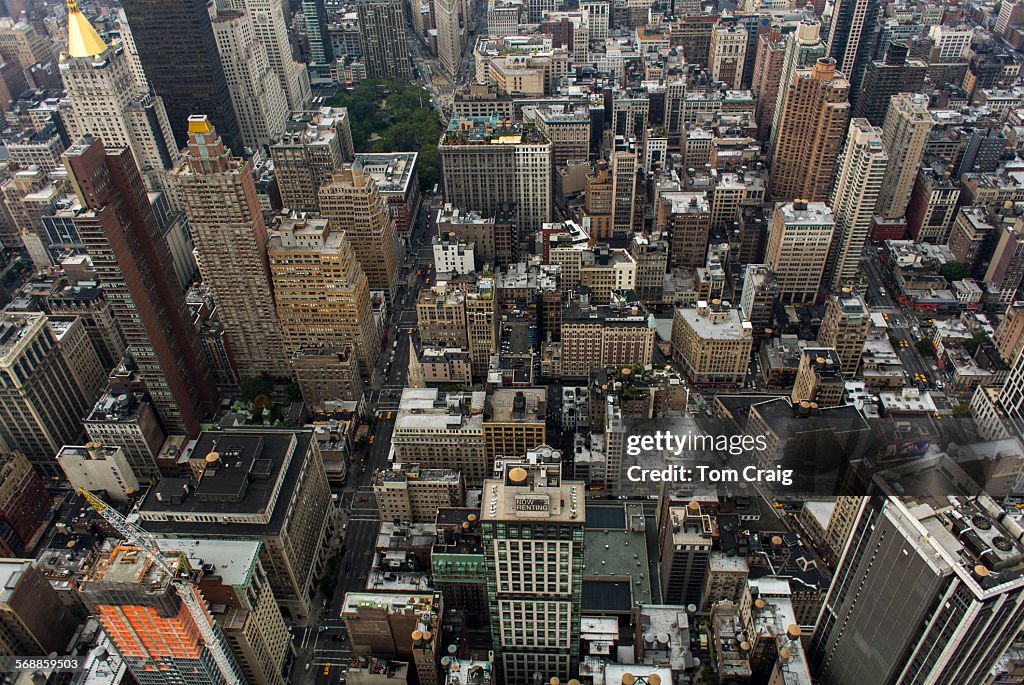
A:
[60, 0, 178, 197]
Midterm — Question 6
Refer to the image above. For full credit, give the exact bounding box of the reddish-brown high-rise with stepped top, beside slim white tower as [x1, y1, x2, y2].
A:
[770, 57, 850, 202]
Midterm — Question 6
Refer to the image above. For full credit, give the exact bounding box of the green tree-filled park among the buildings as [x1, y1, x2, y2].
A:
[331, 79, 441, 189]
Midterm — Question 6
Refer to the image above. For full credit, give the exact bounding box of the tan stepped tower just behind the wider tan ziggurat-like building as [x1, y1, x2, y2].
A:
[319, 163, 398, 300]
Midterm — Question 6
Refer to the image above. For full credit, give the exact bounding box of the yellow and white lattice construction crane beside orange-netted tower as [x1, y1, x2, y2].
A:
[78, 487, 242, 685]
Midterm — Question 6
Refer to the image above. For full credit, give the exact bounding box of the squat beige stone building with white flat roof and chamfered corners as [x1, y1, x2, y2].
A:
[672, 300, 754, 385]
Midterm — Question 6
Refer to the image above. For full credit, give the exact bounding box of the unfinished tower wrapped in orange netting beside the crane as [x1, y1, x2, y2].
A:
[81, 545, 241, 685]
